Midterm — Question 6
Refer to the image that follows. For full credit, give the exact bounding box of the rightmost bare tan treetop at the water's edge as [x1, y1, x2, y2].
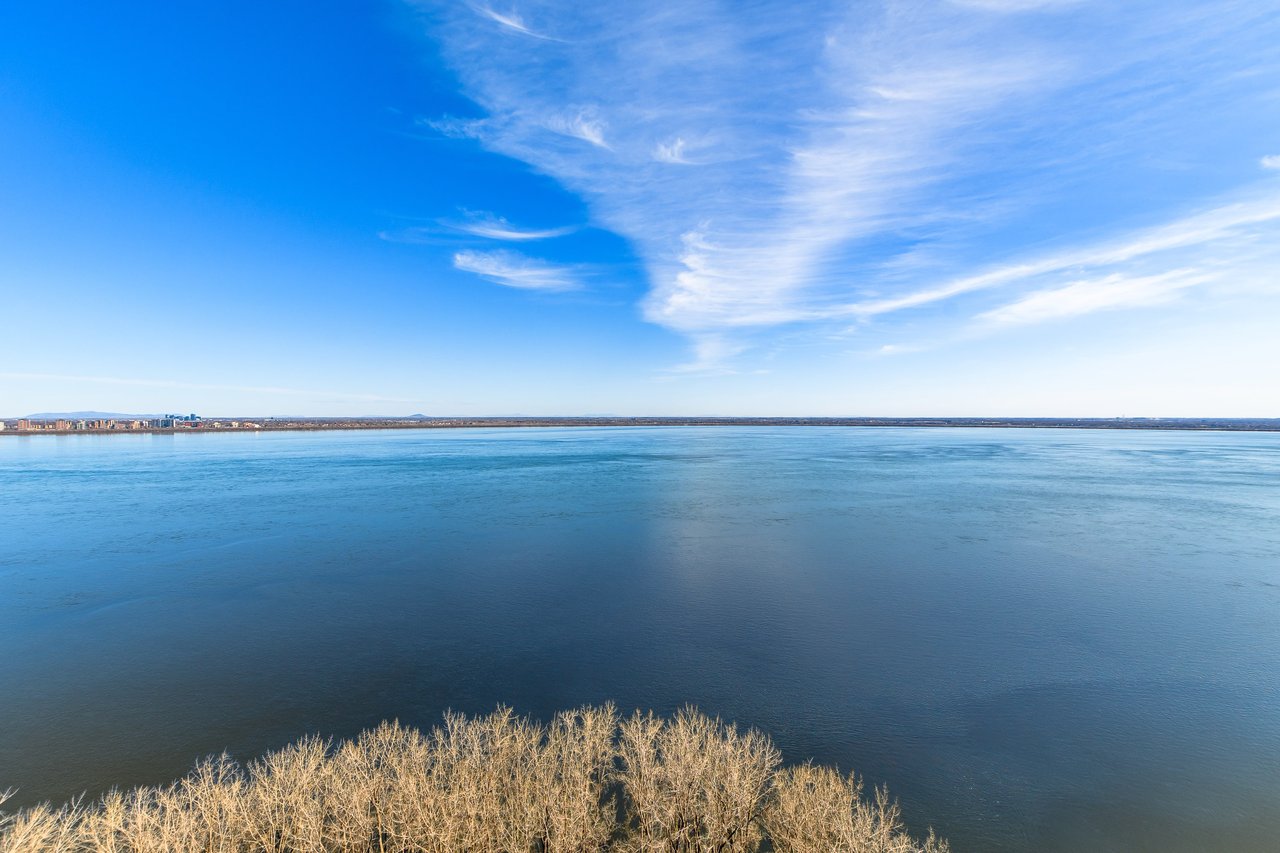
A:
[764, 765, 948, 853]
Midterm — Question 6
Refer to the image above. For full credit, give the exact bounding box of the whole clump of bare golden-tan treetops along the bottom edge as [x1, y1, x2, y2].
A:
[0, 706, 947, 853]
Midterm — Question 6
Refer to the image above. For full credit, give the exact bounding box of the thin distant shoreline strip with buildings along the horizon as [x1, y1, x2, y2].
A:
[0, 418, 1280, 435]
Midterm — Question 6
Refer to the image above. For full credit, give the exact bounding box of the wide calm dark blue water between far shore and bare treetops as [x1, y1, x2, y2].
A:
[0, 428, 1280, 850]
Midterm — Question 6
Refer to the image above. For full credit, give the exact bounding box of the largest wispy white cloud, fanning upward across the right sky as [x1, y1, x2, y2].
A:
[414, 0, 1280, 366]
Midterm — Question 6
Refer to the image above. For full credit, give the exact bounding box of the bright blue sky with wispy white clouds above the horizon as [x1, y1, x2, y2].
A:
[0, 0, 1280, 416]
